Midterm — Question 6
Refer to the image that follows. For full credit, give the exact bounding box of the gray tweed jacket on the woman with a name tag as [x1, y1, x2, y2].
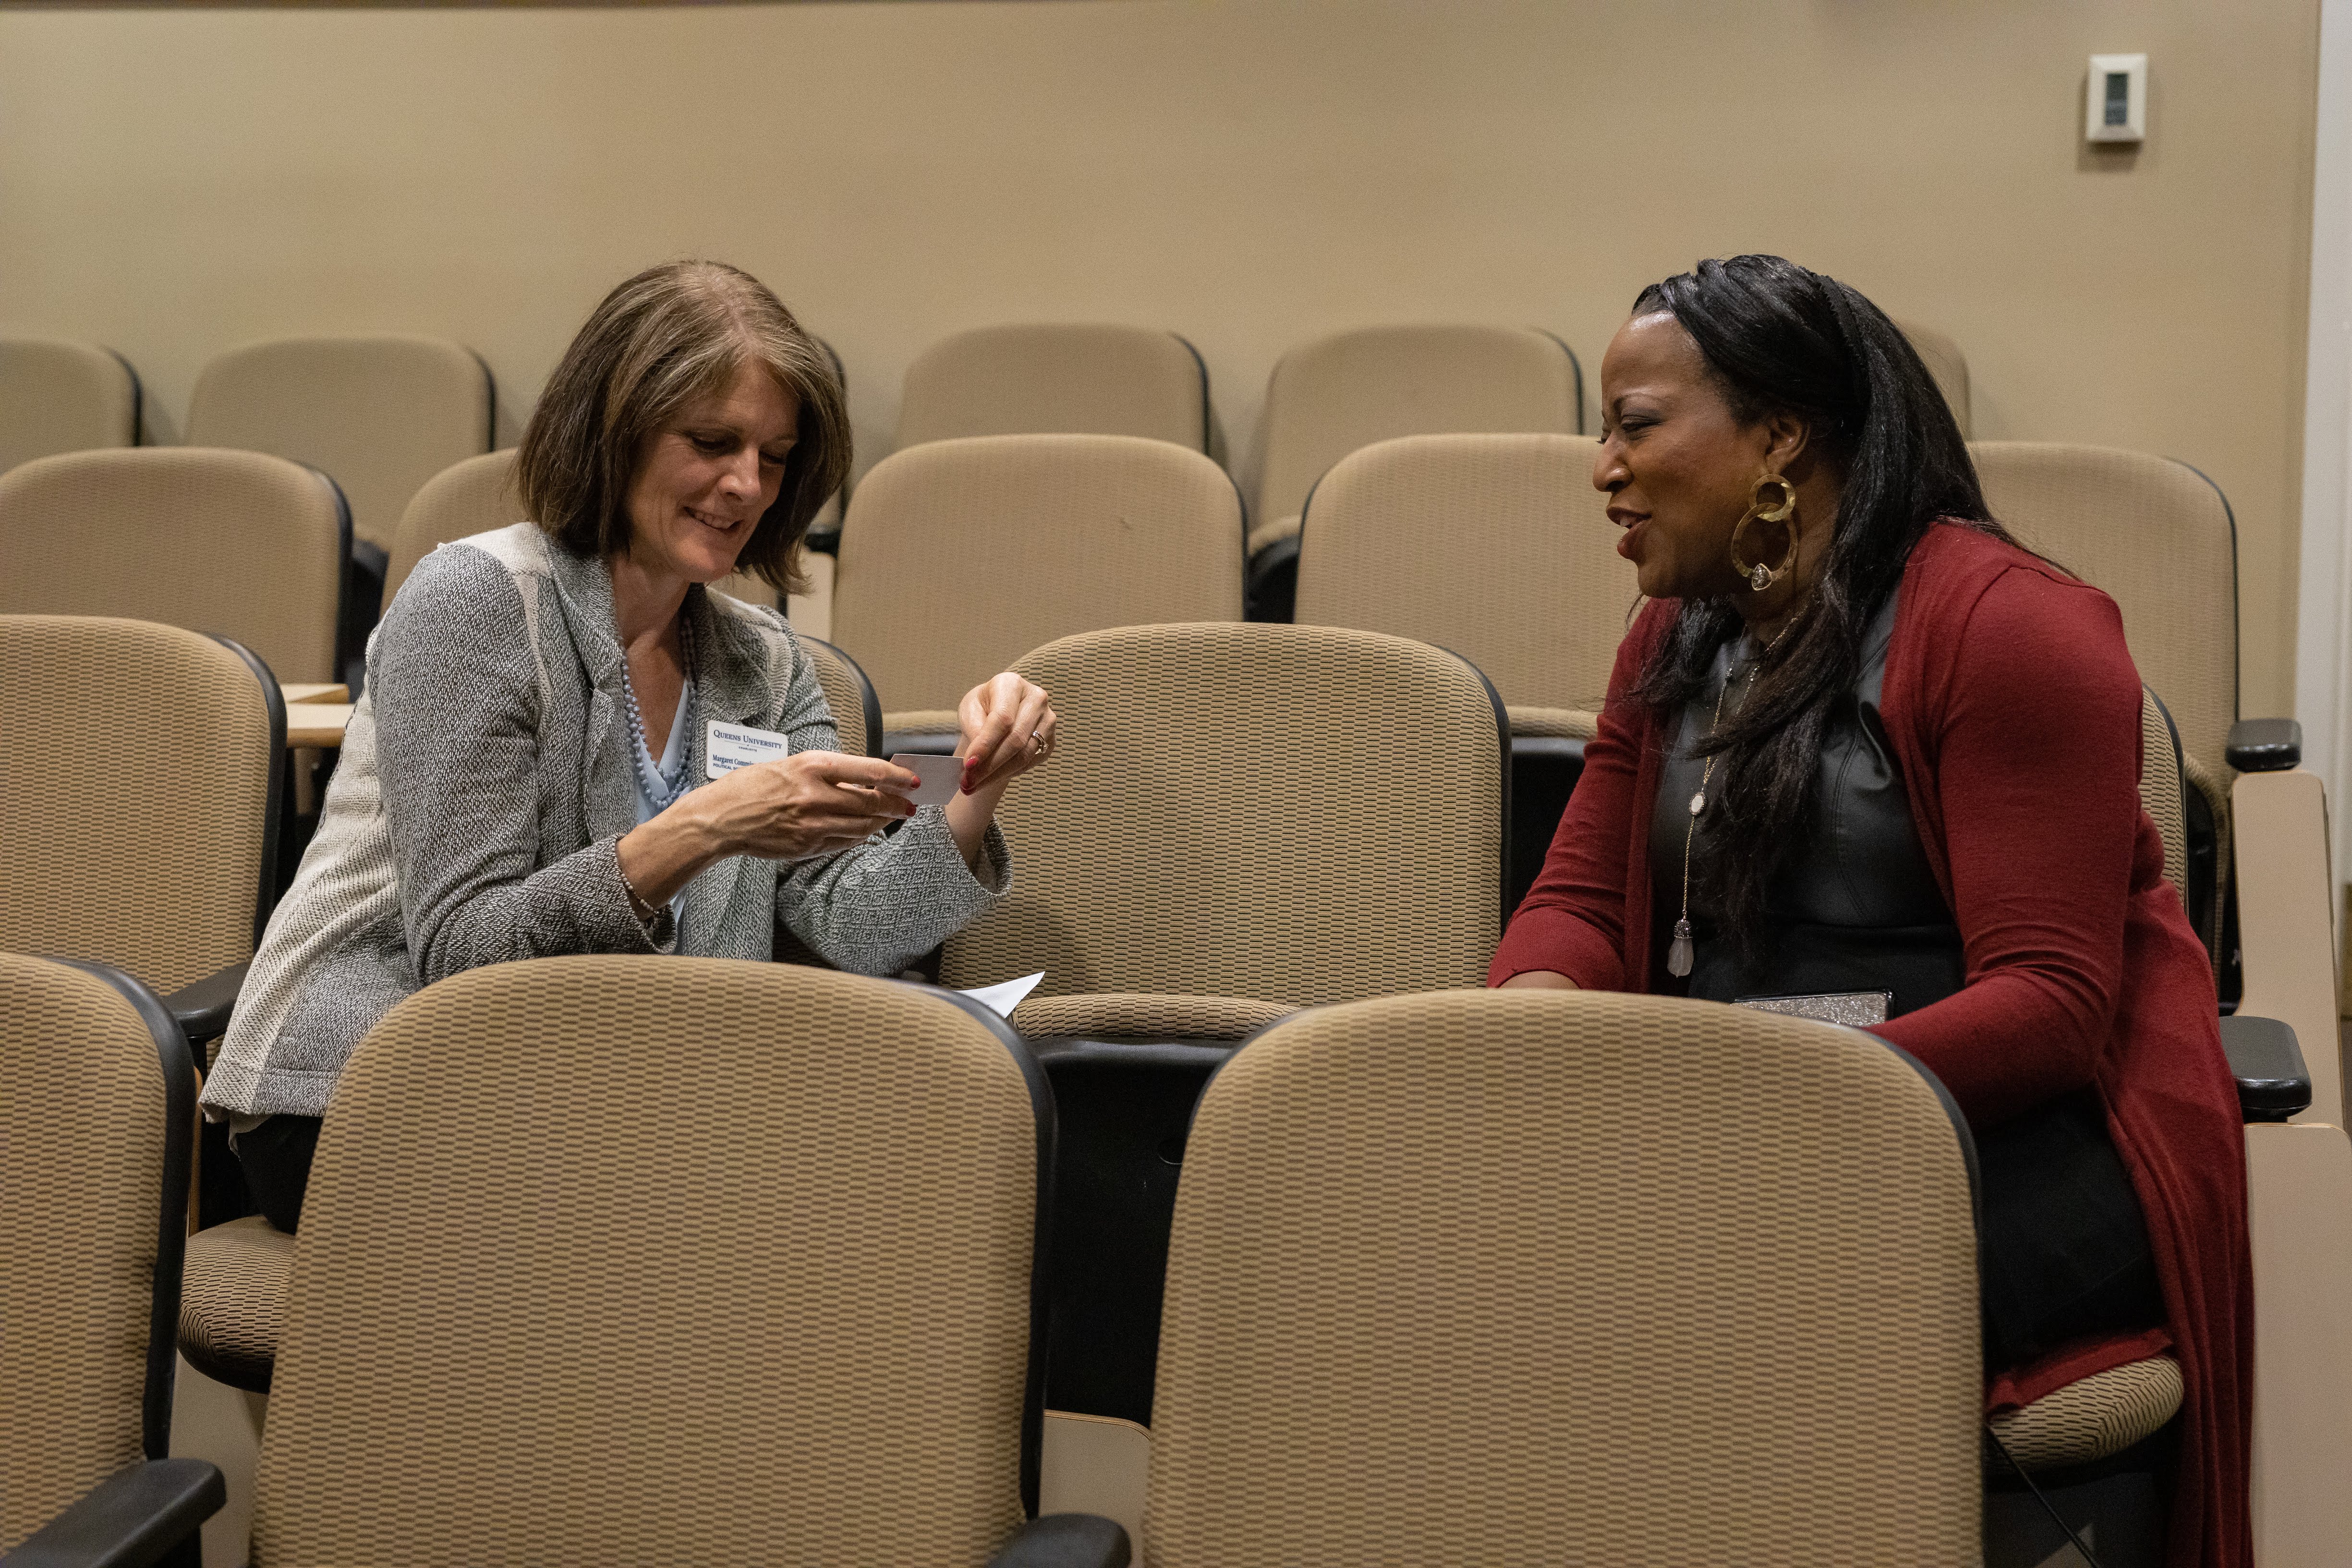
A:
[205, 522, 1009, 1117]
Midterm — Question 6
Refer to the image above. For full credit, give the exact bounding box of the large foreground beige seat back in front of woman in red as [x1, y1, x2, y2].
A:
[1143, 992, 1983, 1568]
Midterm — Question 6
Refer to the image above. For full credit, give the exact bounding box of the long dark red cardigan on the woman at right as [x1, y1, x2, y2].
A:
[1487, 524, 2253, 1568]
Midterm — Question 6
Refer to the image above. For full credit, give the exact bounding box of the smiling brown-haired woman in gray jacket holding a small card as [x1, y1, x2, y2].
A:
[202, 261, 1056, 1229]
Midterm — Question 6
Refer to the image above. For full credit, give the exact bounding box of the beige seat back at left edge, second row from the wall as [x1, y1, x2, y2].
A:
[0, 447, 348, 682]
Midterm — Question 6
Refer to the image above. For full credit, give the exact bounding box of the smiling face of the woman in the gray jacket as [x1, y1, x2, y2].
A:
[628, 362, 800, 583]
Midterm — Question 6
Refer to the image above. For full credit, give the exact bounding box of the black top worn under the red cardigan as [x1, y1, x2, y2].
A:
[1649, 597, 1966, 1016]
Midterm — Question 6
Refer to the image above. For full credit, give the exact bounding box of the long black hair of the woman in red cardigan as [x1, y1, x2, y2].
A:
[1632, 256, 2013, 957]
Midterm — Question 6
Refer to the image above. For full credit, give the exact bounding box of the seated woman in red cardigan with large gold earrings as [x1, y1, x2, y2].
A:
[1489, 256, 2253, 1568]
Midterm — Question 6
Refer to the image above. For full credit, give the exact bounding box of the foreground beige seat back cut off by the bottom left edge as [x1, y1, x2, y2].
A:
[0, 952, 195, 1552]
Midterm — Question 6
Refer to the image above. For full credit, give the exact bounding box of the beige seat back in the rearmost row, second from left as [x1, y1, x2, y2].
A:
[188, 336, 492, 548]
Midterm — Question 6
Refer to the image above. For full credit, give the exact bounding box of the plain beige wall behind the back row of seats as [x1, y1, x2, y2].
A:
[0, 0, 2317, 712]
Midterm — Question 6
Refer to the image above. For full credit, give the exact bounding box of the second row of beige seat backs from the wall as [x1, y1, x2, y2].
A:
[0, 433, 2239, 945]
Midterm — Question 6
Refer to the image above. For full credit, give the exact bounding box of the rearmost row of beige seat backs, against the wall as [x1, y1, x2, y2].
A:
[0, 310, 1969, 576]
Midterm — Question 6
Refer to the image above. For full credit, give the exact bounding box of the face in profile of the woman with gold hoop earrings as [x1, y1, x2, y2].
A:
[1592, 313, 1802, 599]
